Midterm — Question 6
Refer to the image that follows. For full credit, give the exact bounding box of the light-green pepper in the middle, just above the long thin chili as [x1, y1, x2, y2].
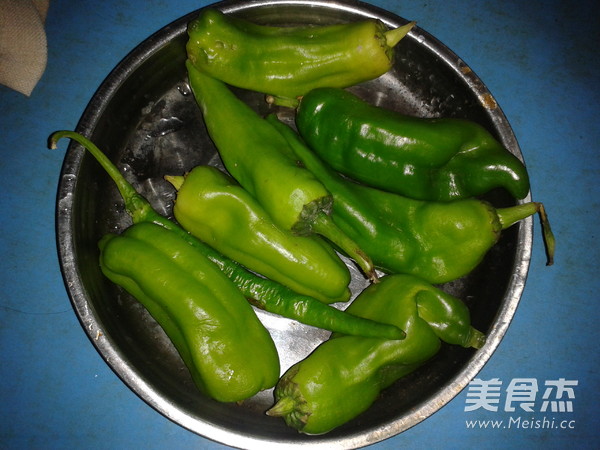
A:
[165, 166, 350, 303]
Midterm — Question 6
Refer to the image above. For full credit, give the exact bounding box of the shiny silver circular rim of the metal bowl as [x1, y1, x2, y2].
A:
[56, 0, 533, 449]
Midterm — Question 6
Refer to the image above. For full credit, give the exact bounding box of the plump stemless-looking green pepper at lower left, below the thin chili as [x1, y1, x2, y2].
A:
[99, 223, 280, 402]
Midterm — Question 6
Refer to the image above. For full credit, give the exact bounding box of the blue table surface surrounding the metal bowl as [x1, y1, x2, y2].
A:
[0, 0, 600, 449]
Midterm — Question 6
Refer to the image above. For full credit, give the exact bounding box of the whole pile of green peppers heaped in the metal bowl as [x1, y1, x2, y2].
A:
[51, 9, 555, 434]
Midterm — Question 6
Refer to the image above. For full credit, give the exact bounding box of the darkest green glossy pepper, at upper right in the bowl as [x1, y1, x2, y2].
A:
[296, 88, 529, 201]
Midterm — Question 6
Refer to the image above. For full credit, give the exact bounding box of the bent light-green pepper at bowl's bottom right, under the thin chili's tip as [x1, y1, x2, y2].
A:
[267, 275, 485, 434]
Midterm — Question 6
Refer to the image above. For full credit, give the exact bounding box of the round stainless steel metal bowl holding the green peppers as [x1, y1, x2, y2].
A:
[57, 0, 532, 448]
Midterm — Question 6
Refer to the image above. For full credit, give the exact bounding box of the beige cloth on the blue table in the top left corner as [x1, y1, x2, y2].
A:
[0, 0, 50, 96]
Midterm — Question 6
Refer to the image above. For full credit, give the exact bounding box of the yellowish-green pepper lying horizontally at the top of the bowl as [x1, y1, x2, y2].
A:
[187, 9, 414, 107]
